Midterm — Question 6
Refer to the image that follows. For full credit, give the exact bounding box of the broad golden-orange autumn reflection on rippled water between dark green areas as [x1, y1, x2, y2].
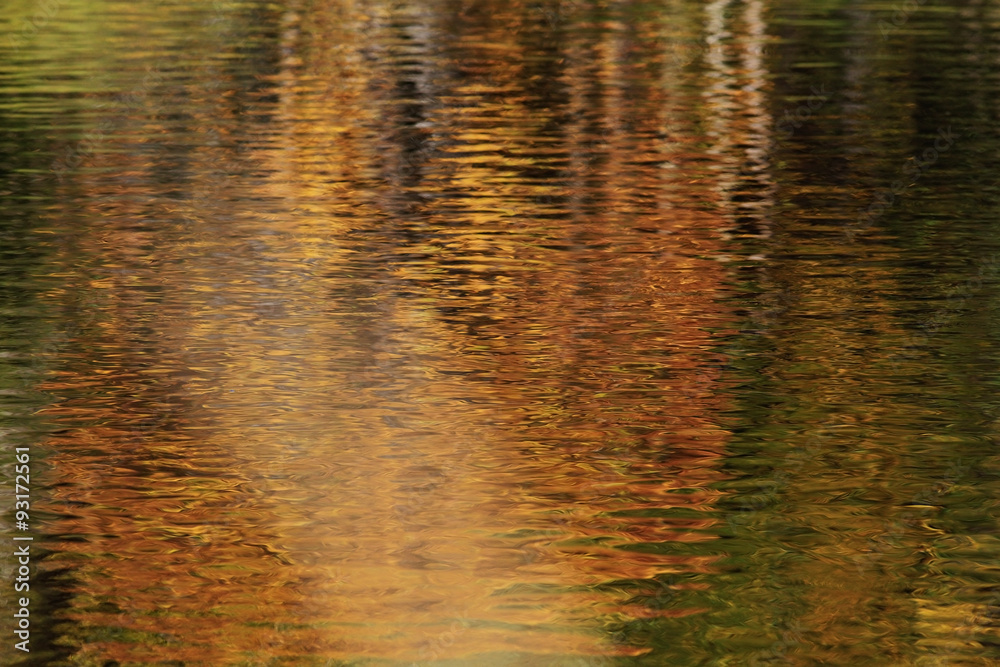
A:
[35, 3, 752, 664]
